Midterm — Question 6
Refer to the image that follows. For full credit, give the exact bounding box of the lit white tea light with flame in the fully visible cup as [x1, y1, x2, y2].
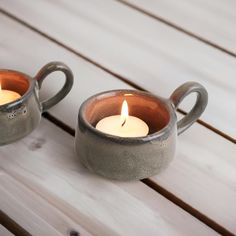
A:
[96, 100, 149, 137]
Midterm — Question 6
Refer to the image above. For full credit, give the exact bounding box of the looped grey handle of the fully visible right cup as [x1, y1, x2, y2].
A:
[170, 82, 208, 135]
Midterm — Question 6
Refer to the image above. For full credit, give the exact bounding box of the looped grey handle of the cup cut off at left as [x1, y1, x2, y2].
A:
[35, 61, 74, 112]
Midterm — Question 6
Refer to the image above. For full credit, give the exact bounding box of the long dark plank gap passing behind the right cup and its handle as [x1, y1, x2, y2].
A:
[0, 8, 233, 144]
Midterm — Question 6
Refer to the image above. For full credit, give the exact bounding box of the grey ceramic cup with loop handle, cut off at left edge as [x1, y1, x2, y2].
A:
[0, 62, 73, 146]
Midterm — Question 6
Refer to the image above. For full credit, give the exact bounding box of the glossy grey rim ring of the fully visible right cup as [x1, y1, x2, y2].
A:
[78, 89, 177, 143]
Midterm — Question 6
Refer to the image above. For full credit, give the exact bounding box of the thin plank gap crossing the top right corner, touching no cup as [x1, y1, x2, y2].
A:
[115, 0, 236, 57]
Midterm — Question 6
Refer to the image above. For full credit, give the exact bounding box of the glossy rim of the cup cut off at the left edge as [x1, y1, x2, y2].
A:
[0, 69, 36, 111]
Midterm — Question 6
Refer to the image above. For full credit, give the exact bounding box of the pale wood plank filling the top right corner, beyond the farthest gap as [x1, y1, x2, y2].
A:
[125, 0, 236, 53]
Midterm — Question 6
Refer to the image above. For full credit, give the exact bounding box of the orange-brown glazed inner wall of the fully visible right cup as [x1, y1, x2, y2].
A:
[84, 91, 170, 134]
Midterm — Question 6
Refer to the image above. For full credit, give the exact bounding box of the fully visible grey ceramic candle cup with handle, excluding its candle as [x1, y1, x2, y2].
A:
[75, 82, 208, 180]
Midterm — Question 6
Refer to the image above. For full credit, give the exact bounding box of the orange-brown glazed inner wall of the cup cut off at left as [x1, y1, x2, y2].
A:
[0, 70, 30, 96]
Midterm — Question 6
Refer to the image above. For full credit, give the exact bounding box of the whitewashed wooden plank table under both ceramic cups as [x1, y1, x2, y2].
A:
[0, 0, 236, 236]
